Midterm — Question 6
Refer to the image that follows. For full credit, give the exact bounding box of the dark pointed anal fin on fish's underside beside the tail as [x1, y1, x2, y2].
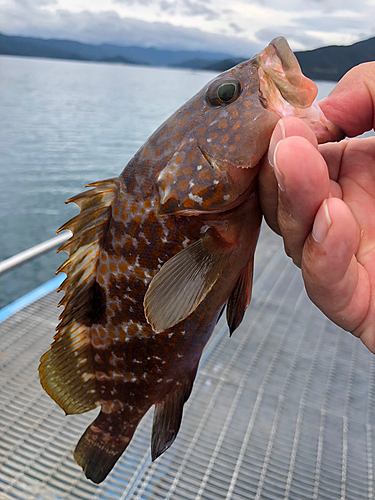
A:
[151, 367, 197, 460]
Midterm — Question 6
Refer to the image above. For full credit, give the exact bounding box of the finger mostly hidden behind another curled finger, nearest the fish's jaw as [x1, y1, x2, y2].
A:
[258, 116, 317, 234]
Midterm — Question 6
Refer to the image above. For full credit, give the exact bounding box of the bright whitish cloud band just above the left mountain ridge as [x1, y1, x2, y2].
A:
[0, 4, 262, 57]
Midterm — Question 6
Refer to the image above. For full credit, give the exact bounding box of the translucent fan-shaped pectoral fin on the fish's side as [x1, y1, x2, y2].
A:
[144, 230, 233, 332]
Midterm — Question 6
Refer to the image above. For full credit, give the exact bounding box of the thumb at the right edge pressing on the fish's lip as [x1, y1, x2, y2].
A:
[319, 62, 375, 137]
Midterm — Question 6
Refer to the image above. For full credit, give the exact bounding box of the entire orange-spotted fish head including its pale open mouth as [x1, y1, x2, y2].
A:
[157, 37, 342, 215]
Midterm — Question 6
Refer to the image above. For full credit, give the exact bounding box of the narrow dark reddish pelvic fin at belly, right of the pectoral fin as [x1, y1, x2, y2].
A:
[227, 258, 254, 336]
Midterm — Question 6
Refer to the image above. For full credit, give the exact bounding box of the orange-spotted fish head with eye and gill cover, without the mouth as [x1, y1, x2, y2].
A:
[156, 61, 279, 215]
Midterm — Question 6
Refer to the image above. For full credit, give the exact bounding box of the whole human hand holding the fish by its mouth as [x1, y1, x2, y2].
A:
[259, 62, 375, 353]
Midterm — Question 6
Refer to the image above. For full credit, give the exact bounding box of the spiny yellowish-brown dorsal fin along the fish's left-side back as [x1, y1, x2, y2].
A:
[39, 179, 117, 414]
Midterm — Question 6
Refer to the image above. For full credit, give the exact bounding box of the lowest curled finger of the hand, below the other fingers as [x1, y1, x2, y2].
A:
[302, 198, 375, 349]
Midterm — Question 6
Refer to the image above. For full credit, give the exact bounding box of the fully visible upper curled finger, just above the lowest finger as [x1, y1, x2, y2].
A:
[274, 133, 330, 266]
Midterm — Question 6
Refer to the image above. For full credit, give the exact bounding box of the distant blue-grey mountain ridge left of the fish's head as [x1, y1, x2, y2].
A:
[0, 34, 235, 66]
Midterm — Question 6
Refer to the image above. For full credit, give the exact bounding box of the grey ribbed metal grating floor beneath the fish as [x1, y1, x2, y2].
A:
[0, 228, 375, 500]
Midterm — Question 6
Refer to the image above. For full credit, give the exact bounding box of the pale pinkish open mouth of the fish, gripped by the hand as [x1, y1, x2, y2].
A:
[251, 36, 345, 143]
